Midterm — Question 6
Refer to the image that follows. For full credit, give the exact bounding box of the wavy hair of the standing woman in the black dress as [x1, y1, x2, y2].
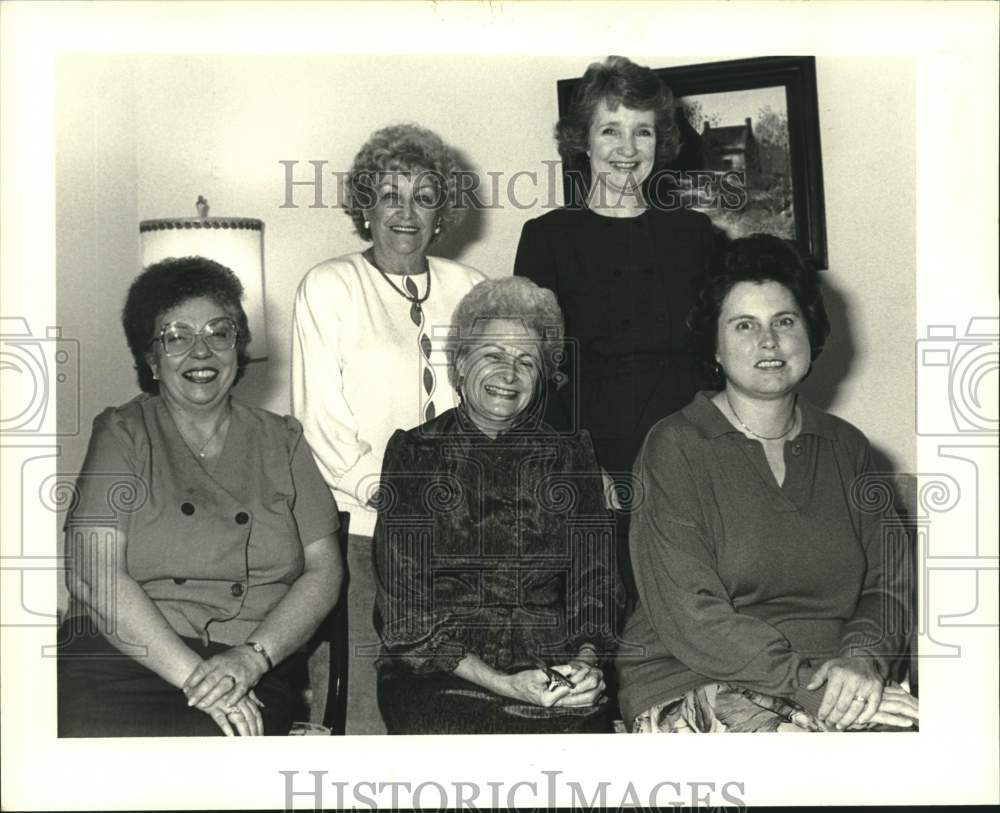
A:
[555, 56, 681, 198]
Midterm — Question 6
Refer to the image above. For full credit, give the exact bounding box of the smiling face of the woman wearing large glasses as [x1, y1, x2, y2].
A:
[147, 297, 237, 410]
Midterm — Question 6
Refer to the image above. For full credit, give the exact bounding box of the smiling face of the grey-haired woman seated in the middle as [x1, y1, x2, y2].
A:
[457, 319, 542, 436]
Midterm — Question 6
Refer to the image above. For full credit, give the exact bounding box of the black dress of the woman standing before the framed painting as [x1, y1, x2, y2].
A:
[514, 208, 716, 481]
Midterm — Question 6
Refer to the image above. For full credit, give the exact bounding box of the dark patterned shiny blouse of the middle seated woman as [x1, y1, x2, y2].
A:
[374, 408, 622, 675]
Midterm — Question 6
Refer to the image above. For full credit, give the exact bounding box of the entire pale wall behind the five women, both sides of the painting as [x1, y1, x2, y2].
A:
[56, 54, 916, 482]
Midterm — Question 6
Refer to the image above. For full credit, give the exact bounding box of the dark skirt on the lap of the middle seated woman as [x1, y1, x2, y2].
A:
[378, 672, 611, 734]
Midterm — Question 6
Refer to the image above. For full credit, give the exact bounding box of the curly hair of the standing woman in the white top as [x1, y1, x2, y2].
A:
[343, 124, 465, 243]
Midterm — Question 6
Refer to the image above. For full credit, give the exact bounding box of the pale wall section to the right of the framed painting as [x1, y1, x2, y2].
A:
[804, 58, 917, 482]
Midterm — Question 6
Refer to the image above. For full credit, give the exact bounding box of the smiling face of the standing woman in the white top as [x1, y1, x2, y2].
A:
[365, 169, 442, 256]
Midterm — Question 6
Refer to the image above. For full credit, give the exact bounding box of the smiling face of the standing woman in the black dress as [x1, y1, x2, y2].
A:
[587, 100, 656, 202]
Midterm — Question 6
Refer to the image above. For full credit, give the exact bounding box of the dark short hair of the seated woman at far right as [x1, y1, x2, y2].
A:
[688, 234, 830, 387]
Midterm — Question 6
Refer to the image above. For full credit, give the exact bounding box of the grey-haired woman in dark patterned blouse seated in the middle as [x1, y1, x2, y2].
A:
[374, 278, 621, 734]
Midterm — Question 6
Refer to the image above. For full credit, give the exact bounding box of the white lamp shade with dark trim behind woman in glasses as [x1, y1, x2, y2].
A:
[139, 198, 267, 359]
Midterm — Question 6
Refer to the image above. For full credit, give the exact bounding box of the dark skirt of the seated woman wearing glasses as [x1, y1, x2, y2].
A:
[57, 619, 294, 737]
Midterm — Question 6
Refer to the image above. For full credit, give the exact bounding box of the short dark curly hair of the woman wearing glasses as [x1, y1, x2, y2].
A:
[122, 257, 250, 395]
